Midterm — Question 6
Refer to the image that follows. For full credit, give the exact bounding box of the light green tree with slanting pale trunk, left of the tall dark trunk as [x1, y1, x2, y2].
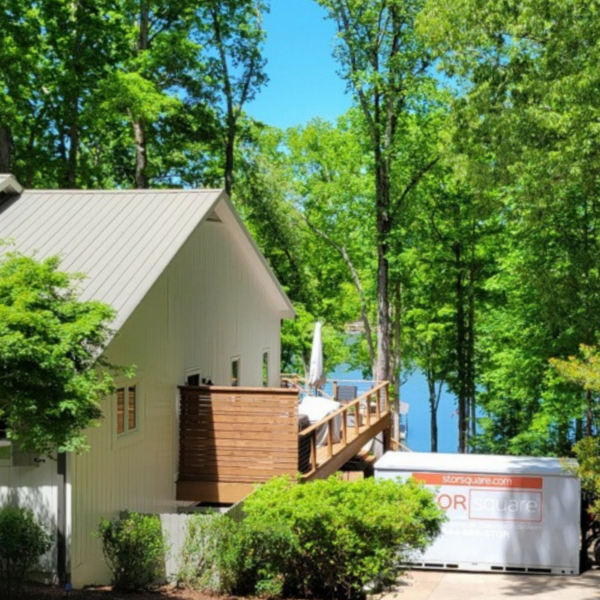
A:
[286, 111, 375, 374]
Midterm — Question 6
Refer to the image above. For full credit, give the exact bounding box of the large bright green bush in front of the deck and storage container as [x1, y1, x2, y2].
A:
[185, 477, 444, 599]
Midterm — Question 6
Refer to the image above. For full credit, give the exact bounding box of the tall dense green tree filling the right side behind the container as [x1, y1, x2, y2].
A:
[420, 0, 600, 453]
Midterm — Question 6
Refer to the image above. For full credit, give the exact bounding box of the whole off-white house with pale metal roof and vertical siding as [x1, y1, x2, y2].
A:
[0, 175, 294, 587]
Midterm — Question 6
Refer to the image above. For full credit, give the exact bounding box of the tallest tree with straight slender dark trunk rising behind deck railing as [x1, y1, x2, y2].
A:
[317, 0, 438, 380]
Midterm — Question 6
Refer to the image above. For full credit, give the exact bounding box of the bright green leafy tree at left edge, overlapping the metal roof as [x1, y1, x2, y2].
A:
[0, 252, 114, 455]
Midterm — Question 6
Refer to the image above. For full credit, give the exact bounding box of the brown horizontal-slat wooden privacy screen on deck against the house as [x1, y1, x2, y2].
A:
[177, 386, 298, 502]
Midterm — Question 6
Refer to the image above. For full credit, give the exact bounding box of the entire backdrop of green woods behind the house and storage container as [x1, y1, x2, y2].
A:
[0, 0, 600, 454]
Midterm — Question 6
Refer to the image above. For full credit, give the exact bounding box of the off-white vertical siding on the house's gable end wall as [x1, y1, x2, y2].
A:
[71, 216, 280, 586]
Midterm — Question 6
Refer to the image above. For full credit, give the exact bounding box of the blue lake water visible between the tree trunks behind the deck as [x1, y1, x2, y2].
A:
[325, 365, 458, 452]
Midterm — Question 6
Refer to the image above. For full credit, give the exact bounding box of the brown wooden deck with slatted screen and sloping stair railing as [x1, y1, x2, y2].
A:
[177, 382, 392, 503]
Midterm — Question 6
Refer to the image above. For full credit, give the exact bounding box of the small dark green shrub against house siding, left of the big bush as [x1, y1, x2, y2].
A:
[98, 513, 167, 591]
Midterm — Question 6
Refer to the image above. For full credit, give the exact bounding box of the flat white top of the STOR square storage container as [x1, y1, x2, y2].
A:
[375, 452, 576, 477]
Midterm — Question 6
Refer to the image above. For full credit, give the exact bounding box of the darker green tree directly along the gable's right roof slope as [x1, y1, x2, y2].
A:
[234, 125, 356, 373]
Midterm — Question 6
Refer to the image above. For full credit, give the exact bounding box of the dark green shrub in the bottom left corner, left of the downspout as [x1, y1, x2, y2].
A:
[0, 506, 51, 597]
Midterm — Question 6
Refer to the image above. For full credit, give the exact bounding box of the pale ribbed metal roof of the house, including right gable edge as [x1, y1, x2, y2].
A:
[0, 183, 293, 329]
